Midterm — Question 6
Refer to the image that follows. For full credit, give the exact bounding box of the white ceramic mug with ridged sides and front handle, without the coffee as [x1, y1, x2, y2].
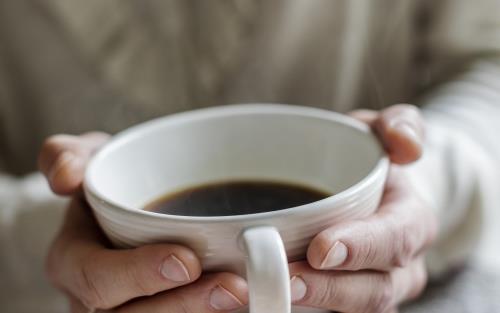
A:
[84, 104, 389, 313]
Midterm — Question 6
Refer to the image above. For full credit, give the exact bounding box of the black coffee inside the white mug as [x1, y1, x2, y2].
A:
[144, 181, 330, 216]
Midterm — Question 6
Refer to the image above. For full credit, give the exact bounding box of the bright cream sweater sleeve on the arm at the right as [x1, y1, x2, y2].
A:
[408, 57, 500, 276]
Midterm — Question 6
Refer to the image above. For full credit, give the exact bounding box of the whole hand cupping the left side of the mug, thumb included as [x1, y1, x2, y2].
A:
[38, 133, 248, 313]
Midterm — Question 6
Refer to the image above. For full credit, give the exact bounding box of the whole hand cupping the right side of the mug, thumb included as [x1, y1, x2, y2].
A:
[290, 105, 437, 313]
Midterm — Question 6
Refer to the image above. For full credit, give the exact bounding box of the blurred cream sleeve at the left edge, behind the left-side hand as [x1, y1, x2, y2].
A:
[0, 172, 66, 312]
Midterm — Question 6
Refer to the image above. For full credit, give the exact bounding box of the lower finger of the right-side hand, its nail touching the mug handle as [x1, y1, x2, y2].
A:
[290, 259, 427, 313]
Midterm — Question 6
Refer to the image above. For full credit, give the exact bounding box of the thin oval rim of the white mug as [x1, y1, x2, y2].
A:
[83, 103, 389, 223]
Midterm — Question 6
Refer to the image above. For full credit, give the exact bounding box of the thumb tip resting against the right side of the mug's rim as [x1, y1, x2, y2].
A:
[372, 104, 424, 164]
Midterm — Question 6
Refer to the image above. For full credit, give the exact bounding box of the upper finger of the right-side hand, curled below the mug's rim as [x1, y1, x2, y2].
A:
[307, 167, 437, 270]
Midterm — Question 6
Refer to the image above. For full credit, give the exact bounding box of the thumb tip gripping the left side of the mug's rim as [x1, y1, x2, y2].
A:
[38, 132, 109, 195]
